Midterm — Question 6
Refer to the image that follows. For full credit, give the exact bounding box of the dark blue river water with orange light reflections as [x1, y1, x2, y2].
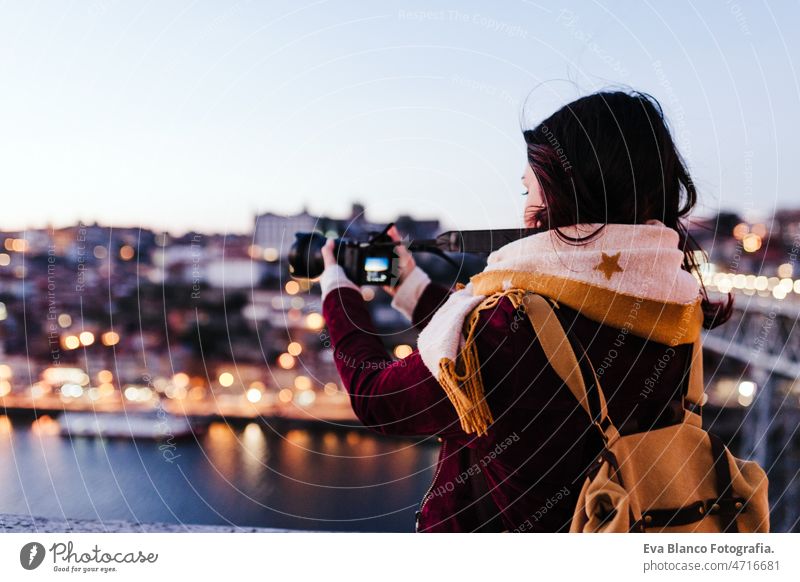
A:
[0, 416, 437, 532]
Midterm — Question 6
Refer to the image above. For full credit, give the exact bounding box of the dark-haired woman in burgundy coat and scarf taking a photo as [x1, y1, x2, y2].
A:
[321, 92, 730, 532]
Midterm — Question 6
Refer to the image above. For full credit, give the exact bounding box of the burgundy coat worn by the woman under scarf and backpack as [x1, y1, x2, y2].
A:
[323, 283, 690, 532]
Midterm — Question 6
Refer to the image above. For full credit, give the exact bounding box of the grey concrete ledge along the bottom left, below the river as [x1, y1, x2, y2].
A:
[0, 513, 296, 533]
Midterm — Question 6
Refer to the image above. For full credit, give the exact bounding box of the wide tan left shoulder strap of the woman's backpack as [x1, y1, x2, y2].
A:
[522, 293, 617, 442]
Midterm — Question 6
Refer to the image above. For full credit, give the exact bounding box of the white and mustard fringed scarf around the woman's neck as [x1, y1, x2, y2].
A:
[417, 221, 702, 435]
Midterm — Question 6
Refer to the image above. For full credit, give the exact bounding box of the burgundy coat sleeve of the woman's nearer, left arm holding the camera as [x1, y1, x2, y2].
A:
[322, 287, 464, 436]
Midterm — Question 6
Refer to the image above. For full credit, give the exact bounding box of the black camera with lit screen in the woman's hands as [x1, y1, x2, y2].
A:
[289, 224, 399, 286]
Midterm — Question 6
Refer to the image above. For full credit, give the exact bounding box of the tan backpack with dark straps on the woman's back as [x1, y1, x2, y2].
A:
[523, 293, 769, 532]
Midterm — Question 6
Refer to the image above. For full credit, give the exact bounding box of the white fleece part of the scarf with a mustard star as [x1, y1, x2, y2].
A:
[417, 221, 699, 383]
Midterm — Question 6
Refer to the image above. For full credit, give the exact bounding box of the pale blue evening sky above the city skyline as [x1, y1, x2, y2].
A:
[0, 0, 800, 234]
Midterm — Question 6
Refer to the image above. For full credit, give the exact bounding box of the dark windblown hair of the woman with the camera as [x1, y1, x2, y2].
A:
[523, 91, 733, 329]
